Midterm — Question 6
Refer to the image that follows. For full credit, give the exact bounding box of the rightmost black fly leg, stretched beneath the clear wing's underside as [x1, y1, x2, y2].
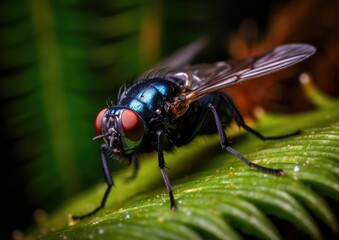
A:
[222, 94, 301, 141]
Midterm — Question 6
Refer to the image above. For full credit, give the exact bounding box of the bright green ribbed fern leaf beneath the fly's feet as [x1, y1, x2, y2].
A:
[26, 83, 339, 239]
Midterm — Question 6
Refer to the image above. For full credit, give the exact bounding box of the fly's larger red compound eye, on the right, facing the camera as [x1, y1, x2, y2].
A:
[121, 109, 144, 142]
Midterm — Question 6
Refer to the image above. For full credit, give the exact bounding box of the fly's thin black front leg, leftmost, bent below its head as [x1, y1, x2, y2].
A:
[72, 144, 114, 220]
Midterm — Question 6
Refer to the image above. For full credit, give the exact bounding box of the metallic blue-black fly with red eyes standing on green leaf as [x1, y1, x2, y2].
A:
[73, 41, 316, 219]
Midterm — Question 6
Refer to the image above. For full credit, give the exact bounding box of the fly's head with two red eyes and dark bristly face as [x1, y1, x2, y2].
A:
[93, 106, 145, 156]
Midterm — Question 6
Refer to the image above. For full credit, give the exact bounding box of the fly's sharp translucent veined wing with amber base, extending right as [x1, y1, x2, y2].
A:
[178, 44, 316, 105]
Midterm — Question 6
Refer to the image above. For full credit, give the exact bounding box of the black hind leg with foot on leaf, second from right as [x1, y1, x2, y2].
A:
[208, 104, 285, 175]
